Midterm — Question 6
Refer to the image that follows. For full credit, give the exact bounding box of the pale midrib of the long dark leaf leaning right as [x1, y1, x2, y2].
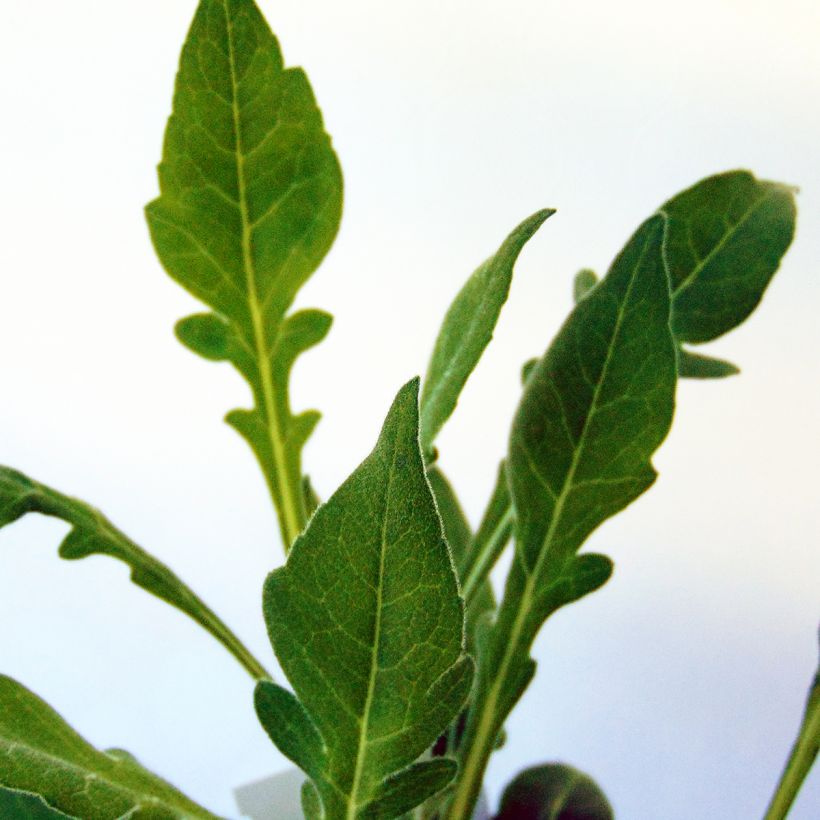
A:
[448, 232, 646, 820]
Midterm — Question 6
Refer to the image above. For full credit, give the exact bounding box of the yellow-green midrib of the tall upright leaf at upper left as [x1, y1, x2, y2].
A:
[222, 0, 302, 552]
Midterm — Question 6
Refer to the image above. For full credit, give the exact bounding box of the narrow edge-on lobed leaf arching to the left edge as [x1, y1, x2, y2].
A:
[0, 466, 268, 678]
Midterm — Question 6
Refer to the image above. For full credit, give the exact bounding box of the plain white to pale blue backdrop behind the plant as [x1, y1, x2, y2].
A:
[0, 0, 820, 820]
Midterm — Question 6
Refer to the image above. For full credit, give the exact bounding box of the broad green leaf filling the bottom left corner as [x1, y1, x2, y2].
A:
[0, 675, 215, 820]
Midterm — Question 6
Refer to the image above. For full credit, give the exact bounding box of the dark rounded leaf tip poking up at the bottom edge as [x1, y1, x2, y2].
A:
[495, 763, 615, 820]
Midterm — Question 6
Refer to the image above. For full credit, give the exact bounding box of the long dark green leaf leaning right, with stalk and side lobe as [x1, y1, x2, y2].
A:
[447, 216, 676, 820]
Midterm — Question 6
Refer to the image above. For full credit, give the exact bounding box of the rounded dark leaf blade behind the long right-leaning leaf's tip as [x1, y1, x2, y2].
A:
[659, 171, 796, 342]
